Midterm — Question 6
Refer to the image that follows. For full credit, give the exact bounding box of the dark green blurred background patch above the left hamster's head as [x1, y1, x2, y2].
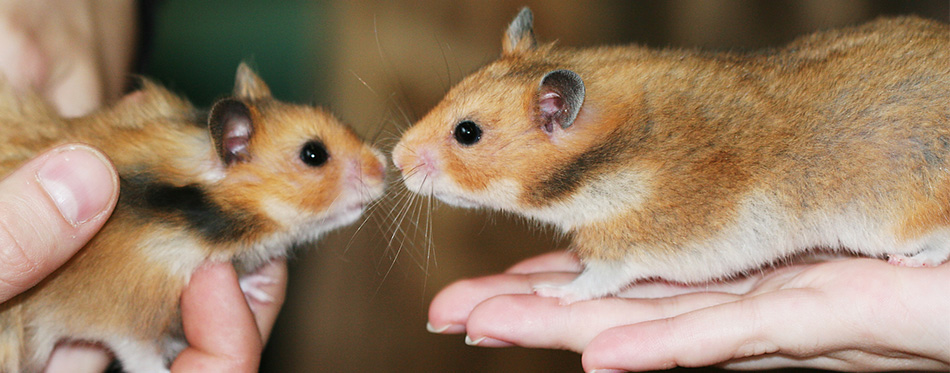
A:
[142, 0, 333, 106]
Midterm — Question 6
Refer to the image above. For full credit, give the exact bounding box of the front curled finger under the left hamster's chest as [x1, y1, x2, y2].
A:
[172, 263, 263, 372]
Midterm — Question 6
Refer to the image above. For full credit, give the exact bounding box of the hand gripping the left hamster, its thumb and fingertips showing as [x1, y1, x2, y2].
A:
[0, 145, 287, 372]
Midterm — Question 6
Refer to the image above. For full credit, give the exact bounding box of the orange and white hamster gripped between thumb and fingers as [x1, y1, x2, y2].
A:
[0, 64, 385, 372]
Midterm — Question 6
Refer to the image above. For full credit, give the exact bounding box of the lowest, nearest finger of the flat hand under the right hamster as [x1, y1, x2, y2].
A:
[583, 290, 847, 371]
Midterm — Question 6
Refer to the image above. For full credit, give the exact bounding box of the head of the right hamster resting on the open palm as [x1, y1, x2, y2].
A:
[393, 8, 624, 230]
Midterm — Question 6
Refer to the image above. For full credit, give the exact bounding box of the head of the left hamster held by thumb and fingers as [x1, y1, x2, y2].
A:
[209, 64, 385, 251]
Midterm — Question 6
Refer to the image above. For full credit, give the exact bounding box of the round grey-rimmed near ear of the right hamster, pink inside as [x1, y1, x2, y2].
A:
[538, 70, 585, 133]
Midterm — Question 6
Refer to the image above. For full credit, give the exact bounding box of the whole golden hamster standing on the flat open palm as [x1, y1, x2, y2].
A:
[392, 8, 950, 304]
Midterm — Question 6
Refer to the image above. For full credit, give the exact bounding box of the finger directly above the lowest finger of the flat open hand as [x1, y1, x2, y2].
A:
[466, 293, 738, 352]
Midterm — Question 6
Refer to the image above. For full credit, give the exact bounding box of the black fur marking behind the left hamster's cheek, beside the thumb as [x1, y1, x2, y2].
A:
[119, 175, 255, 243]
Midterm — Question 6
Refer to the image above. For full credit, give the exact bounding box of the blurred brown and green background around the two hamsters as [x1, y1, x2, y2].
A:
[141, 0, 950, 372]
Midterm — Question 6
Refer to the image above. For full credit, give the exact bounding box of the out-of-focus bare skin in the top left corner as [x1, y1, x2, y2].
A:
[0, 0, 136, 117]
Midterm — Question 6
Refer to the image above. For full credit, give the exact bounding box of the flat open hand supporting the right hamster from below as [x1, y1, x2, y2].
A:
[429, 252, 950, 371]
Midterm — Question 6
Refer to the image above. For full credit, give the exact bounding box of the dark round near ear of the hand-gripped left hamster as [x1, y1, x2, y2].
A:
[208, 98, 254, 166]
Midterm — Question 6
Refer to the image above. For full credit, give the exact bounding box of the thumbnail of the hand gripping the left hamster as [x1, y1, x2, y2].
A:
[36, 145, 115, 226]
